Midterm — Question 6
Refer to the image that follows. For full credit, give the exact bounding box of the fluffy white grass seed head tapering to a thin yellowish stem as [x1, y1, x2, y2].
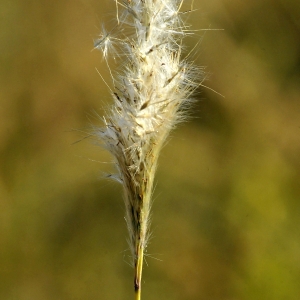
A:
[95, 0, 200, 300]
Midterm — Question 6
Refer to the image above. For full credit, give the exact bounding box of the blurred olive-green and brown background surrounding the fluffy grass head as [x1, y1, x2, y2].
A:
[0, 0, 300, 300]
